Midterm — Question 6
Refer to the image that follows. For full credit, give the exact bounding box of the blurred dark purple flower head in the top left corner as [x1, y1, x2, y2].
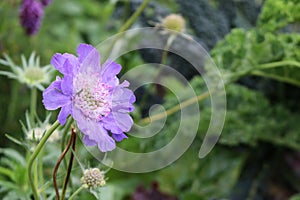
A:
[19, 0, 44, 35]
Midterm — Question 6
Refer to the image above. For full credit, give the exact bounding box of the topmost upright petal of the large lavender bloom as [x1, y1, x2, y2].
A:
[77, 44, 101, 72]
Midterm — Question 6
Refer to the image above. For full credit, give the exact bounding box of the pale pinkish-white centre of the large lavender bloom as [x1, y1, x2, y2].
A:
[73, 72, 111, 121]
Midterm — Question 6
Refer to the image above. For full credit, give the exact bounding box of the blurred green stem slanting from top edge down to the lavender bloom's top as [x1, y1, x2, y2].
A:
[103, 0, 150, 60]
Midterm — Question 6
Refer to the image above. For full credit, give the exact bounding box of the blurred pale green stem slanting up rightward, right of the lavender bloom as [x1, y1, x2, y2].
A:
[140, 92, 210, 124]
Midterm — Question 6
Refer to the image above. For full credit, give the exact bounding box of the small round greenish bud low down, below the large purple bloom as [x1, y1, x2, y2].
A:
[81, 168, 106, 188]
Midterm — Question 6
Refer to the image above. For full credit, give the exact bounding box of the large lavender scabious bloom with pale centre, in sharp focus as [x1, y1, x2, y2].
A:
[43, 44, 135, 152]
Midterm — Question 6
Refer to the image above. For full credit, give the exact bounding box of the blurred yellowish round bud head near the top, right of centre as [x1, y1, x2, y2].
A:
[161, 14, 185, 32]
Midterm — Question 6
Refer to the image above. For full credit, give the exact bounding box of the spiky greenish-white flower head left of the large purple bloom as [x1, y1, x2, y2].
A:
[0, 52, 54, 91]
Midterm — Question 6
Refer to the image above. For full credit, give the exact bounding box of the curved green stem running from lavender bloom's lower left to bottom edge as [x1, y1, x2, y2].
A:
[27, 121, 59, 200]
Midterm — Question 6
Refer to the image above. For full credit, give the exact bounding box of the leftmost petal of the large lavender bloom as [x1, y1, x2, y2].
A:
[43, 78, 71, 110]
